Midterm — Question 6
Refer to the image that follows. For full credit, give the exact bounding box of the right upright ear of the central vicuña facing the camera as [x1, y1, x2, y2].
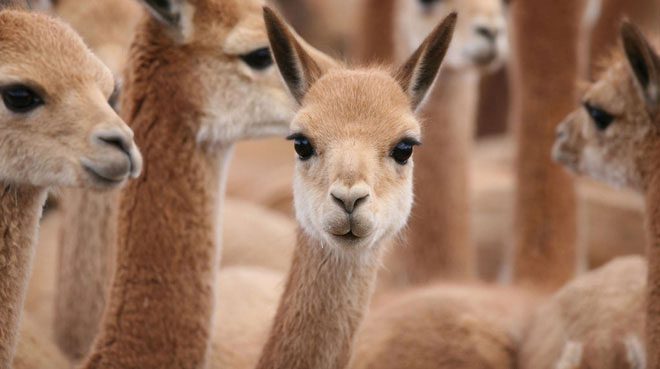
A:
[397, 13, 457, 110]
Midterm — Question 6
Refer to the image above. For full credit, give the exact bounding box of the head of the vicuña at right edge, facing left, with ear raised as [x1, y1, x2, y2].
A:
[553, 23, 660, 190]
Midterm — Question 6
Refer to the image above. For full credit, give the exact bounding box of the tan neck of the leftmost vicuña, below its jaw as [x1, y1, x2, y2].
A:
[0, 183, 46, 369]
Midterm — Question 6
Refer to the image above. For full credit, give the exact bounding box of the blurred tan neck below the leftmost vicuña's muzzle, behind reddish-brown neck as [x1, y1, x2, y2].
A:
[53, 188, 119, 360]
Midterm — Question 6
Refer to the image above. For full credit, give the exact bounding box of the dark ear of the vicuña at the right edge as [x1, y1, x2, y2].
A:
[621, 21, 660, 115]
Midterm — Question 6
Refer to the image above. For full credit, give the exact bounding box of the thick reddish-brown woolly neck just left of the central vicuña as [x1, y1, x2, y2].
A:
[85, 23, 232, 369]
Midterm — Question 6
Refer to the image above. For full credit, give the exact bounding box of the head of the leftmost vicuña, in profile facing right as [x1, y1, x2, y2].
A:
[0, 10, 142, 189]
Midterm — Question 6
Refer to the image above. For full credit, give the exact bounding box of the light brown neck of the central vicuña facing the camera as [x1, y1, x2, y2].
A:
[257, 232, 379, 369]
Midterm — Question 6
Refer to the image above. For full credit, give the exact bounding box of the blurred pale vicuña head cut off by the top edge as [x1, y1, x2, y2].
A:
[395, 0, 508, 69]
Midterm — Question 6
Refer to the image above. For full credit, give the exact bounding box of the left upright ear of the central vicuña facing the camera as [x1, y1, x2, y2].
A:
[264, 6, 327, 104]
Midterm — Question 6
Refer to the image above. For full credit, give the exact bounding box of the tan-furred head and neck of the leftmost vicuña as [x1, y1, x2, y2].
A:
[0, 10, 142, 369]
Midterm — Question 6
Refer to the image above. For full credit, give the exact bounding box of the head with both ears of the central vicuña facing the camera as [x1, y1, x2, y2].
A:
[265, 9, 456, 251]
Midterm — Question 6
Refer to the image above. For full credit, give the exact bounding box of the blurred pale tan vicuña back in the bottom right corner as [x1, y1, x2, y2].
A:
[519, 256, 646, 369]
